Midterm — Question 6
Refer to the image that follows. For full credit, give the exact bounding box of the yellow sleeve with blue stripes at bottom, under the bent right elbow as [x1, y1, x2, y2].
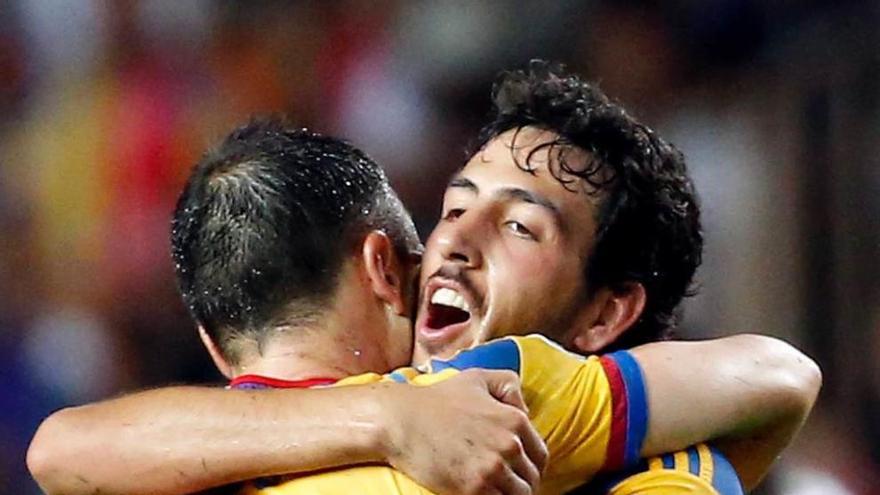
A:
[572, 444, 745, 495]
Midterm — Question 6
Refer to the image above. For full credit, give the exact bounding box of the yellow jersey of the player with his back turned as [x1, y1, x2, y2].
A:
[239, 335, 744, 495]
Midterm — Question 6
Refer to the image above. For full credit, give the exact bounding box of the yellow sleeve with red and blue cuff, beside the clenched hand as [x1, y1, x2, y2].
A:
[422, 335, 648, 492]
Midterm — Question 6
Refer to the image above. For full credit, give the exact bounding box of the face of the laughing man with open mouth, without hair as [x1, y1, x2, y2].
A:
[413, 127, 596, 364]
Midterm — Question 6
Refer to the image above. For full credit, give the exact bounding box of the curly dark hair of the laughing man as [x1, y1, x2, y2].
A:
[470, 61, 703, 348]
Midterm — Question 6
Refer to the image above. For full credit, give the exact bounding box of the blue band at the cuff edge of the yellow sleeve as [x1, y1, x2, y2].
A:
[609, 351, 648, 465]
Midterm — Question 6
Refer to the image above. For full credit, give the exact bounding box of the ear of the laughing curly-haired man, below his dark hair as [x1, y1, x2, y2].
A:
[569, 282, 646, 354]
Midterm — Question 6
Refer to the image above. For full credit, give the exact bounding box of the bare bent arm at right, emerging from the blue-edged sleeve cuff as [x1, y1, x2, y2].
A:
[632, 335, 822, 490]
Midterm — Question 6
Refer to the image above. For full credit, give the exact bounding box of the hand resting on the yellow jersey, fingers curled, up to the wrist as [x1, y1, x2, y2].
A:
[384, 370, 547, 495]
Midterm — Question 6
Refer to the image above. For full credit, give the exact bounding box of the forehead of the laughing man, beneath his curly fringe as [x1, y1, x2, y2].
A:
[457, 127, 596, 225]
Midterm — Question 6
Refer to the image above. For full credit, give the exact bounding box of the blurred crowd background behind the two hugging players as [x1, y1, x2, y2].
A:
[0, 0, 880, 495]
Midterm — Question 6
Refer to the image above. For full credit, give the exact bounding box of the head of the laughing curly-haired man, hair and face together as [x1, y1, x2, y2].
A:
[416, 61, 703, 366]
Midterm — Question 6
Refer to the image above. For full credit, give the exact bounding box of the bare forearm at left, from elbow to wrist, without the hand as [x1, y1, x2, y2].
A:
[27, 385, 396, 494]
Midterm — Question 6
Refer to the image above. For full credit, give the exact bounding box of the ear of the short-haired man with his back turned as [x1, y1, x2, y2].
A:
[361, 230, 407, 315]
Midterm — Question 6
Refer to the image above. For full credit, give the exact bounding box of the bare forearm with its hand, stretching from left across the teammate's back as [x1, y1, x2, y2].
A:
[27, 371, 546, 495]
